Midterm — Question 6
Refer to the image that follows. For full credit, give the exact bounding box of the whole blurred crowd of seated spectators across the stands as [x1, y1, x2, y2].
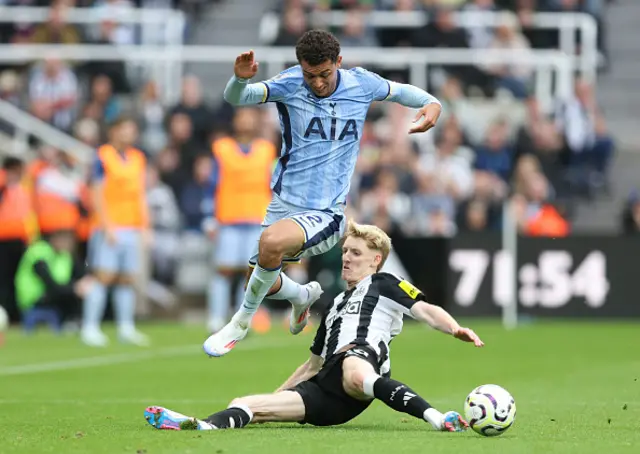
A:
[0, 0, 640, 320]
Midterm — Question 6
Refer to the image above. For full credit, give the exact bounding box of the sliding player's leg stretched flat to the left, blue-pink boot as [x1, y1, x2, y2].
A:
[144, 391, 305, 430]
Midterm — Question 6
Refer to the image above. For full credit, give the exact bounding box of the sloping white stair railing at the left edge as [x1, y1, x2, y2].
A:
[0, 99, 94, 162]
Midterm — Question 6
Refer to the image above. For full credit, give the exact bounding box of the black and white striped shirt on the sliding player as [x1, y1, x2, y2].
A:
[311, 273, 425, 374]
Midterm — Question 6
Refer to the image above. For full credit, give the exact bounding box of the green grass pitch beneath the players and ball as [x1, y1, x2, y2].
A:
[0, 321, 640, 454]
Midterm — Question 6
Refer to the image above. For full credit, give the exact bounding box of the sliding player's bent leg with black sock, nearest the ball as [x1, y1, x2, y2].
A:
[342, 356, 468, 432]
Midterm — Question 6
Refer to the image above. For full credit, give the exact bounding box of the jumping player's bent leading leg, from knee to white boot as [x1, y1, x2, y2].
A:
[203, 219, 319, 356]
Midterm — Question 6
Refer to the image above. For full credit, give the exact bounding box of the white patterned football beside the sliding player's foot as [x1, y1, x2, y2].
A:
[464, 385, 516, 437]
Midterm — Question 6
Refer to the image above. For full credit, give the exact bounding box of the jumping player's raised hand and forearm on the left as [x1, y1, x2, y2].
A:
[224, 50, 268, 106]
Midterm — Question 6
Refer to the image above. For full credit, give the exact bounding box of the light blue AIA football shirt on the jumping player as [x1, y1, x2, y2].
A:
[225, 65, 439, 210]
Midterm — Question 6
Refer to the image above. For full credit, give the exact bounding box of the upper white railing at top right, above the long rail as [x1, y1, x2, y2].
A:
[260, 11, 599, 82]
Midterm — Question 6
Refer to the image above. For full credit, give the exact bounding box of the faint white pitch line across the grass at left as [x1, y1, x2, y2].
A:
[0, 341, 292, 377]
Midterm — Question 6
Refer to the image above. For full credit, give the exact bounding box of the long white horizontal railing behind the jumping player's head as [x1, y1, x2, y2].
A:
[0, 44, 573, 115]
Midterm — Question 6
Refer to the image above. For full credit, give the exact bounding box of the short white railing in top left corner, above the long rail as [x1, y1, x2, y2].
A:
[0, 6, 186, 102]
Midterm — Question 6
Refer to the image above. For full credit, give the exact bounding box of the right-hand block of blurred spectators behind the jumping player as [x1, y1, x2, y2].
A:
[262, 0, 615, 236]
